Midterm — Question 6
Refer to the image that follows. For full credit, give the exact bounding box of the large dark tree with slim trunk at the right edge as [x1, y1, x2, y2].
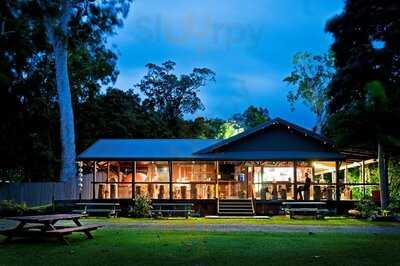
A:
[327, 0, 400, 208]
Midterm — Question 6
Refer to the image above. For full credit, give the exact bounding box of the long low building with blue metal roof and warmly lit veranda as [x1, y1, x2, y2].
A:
[78, 118, 377, 213]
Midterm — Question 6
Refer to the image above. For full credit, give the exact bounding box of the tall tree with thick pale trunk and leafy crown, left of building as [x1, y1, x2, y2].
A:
[33, 0, 129, 181]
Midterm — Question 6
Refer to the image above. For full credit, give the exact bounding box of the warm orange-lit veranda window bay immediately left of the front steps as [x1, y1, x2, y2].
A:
[172, 162, 216, 199]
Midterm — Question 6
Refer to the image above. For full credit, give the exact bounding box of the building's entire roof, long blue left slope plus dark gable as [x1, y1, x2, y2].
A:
[78, 118, 344, 161]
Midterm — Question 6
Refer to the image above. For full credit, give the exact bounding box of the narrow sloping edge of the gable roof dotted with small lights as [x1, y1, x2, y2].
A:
[196, 117, 334, 154]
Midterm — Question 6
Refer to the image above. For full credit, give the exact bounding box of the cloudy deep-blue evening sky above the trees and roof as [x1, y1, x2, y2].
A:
[110, 0, 343, 128]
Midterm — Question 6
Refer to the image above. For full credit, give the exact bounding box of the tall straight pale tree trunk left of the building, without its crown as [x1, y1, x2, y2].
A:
[51, 34, 76, 181]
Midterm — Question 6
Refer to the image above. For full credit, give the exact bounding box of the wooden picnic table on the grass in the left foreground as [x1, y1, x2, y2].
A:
[0, 214, 102, 245]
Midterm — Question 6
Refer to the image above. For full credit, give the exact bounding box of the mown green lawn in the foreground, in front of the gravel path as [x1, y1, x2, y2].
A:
[0, 229, 400, 266]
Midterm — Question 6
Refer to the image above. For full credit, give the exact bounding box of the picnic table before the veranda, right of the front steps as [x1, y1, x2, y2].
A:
[282, 201, 329, 219]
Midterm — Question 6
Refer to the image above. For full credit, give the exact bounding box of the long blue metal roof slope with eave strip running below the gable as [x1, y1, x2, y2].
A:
[78, 139, 344, 161]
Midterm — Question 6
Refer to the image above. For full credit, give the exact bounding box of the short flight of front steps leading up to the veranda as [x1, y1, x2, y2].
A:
[217, 199, 255, 216]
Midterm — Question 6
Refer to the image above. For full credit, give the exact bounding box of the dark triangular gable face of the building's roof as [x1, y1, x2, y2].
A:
[196, 118, 335, 154]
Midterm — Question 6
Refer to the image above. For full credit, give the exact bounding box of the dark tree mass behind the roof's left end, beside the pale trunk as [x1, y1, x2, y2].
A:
[76, 88, 166, 152]
